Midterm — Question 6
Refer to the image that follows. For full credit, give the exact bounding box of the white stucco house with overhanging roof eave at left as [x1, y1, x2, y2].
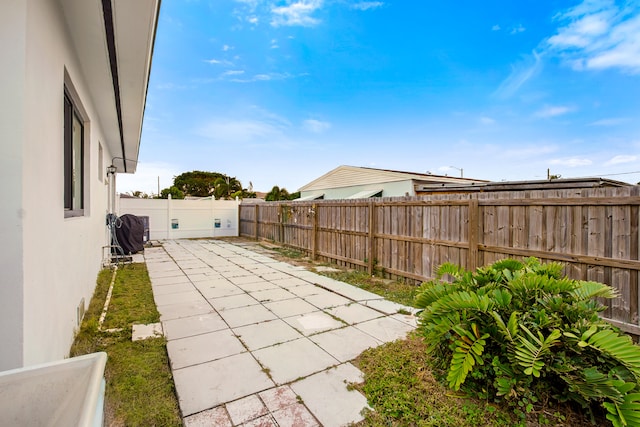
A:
[0, 0, 160, 371]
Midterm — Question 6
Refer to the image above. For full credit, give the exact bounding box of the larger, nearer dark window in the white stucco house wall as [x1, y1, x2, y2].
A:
[64, 90, 84, 217]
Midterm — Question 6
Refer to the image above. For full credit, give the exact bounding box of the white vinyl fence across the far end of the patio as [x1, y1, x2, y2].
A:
[117, 197, 240, 240]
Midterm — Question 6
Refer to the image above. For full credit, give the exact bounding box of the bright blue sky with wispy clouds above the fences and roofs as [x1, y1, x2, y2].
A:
[118, 0, 640, 193]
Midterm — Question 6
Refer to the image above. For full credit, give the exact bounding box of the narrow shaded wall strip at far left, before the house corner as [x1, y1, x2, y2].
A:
[0, 0, 27, 371]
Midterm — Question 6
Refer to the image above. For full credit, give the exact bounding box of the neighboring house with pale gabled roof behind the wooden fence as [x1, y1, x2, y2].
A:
[296, 166, 488, 200]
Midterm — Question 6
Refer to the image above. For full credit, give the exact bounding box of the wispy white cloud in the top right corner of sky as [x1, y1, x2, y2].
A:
[546, 0, 640, 74]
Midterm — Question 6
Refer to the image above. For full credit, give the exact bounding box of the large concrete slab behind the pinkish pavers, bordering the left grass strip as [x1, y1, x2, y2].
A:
[173, 353, 274, 416]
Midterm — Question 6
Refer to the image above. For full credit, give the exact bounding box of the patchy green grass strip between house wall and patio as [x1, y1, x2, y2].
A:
[71, 264, 182, 426]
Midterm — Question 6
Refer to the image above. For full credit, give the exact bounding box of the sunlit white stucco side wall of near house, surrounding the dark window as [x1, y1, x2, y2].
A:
[0, 0, 112, 370]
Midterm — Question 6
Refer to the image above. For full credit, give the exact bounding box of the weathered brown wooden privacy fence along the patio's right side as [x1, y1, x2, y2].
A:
[240, 186, 640, 334]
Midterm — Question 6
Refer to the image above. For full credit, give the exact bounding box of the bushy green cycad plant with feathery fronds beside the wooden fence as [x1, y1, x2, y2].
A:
[416, 258, 640, 427]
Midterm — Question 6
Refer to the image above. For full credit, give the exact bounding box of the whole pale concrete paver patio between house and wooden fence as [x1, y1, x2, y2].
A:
[145, 240, 416, 427]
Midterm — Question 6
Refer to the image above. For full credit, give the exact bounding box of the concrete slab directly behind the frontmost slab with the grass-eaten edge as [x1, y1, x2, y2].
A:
[253, 338, 338, 385]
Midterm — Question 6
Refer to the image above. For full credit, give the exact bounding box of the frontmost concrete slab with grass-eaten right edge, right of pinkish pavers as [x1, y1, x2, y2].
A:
[291, 363, 369, 426]
